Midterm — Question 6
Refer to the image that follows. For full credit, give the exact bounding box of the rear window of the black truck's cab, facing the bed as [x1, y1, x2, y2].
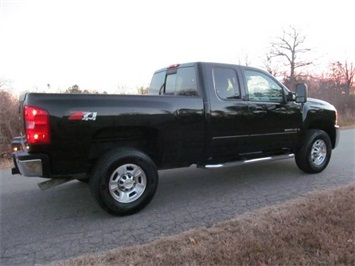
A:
[149, 67, 198, 96]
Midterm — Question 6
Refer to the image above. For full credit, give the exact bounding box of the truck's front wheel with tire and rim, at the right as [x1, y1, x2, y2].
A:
[295, 129, 332, 174]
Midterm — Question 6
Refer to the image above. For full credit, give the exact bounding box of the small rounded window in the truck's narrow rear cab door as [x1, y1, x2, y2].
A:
[212, 67, 240, 100]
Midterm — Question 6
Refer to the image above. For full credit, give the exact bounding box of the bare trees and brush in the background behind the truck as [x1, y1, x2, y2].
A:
[0, 26, 355, 158]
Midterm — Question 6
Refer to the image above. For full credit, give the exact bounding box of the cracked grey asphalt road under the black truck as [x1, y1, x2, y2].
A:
[0, 129, 355, 265]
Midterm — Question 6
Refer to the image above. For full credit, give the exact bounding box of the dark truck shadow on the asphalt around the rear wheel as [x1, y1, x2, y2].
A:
[4, 161, 314, 219]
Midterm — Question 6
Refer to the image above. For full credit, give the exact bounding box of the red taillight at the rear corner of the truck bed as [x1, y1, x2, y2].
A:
[25, 106, 50, 144]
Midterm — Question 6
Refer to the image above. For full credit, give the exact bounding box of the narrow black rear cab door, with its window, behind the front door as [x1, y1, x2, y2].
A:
[204, 63, 250, 161]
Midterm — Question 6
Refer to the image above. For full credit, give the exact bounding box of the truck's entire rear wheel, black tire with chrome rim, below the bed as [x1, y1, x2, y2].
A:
[90, 150, 158, 216]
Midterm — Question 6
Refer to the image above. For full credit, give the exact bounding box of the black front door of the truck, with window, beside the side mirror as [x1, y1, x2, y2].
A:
[242, 67, 302, 152]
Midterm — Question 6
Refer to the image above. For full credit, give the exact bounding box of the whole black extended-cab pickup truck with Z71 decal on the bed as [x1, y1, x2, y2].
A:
[12, 62, 339, 215]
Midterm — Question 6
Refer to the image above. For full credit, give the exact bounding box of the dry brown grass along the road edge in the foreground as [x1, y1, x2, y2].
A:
[48, 184, 355, 266]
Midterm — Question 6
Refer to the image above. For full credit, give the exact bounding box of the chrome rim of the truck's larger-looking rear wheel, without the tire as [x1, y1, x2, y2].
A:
[109, 164, 147, 203]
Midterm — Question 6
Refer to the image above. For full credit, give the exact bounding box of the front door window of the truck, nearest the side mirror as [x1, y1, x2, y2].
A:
[245, 70, 283, 102]
